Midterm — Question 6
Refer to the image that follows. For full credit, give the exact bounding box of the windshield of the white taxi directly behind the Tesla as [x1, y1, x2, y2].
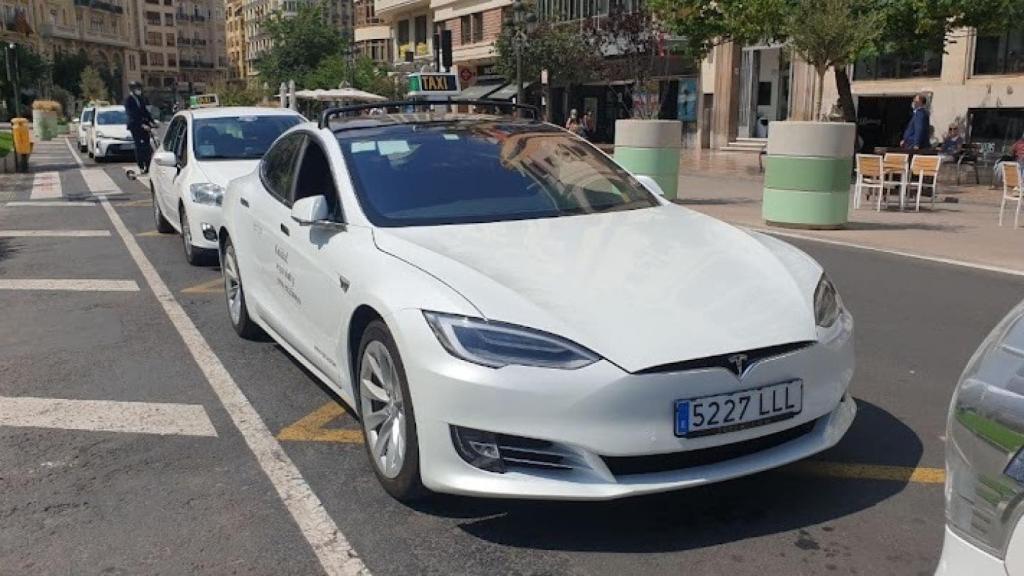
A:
[193, 115, 301, 160]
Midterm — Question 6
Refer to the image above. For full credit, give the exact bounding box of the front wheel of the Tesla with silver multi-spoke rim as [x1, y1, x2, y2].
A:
[356, 320, 427, 502]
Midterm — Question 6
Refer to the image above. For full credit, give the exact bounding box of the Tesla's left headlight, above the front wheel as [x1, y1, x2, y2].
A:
[423, 312, 601, 370]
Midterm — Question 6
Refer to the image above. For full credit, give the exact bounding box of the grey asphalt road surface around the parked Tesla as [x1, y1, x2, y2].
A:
[0, 140, 1024, 576]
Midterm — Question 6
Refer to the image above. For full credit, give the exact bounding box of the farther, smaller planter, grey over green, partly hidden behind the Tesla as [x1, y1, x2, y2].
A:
[615, 120, 683, 200]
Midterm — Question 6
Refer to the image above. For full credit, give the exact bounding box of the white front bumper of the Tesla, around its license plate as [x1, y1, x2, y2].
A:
[394, 311, 856, 500]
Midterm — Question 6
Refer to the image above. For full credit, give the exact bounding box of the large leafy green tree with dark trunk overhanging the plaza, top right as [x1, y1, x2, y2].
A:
[650, 0, 1024, 121]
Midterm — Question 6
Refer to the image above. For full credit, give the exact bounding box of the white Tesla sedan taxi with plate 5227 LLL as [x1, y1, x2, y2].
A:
[219, 107, 856, 499]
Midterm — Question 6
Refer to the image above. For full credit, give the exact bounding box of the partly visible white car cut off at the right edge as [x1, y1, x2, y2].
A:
[936, 302, 1024, 576]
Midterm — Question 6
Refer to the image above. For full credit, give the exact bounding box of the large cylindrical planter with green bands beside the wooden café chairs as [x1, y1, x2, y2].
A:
[762, 122, 856, 229]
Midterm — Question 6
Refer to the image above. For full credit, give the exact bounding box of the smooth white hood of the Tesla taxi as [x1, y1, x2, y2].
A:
[375, 205, 820, 372]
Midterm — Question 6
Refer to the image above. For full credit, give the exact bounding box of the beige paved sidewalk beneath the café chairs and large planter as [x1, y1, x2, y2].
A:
[678, 151, 1024, 275]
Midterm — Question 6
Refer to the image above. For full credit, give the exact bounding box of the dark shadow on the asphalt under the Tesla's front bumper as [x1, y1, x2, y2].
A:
[415, 401, 923, 552]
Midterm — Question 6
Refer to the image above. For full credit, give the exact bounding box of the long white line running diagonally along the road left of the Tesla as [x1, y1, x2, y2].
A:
[100, 197, 370, 576]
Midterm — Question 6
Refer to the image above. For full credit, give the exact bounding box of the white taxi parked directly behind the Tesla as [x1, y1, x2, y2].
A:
[150, 107, 303, 264]
